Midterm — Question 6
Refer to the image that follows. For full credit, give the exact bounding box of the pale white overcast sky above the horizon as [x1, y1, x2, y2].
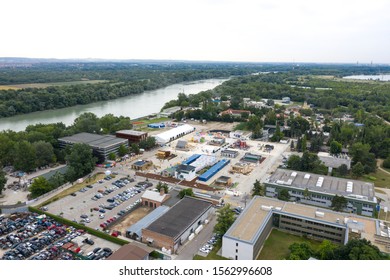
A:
[0, 0, 390, 63]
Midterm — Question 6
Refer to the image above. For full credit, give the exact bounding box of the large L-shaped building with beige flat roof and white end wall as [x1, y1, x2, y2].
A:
[222, 196, 390, 260]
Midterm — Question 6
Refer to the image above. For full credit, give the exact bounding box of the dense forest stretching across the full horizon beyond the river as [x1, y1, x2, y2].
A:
[0, 62, 390, 119]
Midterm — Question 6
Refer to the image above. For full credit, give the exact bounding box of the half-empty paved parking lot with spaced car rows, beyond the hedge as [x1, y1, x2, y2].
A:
[44, 176, 151, 230]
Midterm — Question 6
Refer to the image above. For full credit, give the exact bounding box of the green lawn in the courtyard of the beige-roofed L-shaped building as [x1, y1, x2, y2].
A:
[257, 229, 321, 260]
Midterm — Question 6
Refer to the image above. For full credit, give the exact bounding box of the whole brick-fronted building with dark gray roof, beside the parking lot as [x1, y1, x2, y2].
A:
[142, 197, 213, 253]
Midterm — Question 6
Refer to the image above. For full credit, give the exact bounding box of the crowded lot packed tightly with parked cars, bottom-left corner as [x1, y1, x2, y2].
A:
[0, 213, 120, 260]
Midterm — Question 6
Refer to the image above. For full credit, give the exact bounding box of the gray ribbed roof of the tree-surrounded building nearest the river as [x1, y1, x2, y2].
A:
[58, 132, 127, 149]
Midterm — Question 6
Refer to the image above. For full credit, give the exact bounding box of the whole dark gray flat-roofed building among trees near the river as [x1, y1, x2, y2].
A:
[58, 132, 129, 162]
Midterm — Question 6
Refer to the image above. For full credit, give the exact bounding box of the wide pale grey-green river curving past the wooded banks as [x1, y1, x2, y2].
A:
[0, 79, 228, 131]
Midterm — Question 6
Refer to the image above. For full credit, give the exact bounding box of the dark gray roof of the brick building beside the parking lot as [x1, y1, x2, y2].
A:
[147, 197, 212, 239]
